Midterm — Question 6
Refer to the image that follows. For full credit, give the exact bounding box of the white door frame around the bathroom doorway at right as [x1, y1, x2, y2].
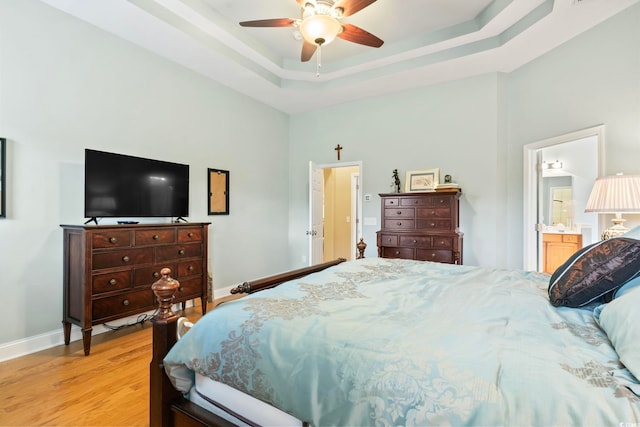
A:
[523, 125, 606, 271]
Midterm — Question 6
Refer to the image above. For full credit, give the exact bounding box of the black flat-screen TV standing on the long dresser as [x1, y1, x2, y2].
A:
[84, 149, 189, 218]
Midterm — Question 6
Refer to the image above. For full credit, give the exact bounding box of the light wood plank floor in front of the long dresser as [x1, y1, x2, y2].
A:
[0, 304, 206, 426]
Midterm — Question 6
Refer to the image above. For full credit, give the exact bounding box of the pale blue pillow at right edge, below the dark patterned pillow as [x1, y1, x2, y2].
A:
[596, 287, 640, 379]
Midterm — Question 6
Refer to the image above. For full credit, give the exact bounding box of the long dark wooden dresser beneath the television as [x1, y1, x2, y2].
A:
[61, 223, 210, 355]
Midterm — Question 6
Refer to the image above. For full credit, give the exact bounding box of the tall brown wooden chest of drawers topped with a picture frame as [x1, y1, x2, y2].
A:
[377, 190, 463, 264]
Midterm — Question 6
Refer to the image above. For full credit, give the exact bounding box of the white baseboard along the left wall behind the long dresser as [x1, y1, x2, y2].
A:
[0, 300, 202, 362]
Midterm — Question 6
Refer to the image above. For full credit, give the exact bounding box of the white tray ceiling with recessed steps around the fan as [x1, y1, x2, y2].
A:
[41, 0, 640, 113]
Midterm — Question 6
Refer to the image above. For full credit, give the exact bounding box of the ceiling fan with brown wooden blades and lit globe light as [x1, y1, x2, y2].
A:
[240, 0, 384, 62]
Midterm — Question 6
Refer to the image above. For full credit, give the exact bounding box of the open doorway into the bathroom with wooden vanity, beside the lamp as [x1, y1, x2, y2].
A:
[523, 126, 604, 272]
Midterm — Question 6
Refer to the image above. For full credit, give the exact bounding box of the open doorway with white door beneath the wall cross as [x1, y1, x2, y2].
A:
[308, 162, 362, 265]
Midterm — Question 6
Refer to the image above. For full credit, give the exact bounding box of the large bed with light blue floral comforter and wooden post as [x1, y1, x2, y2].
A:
[151, 247, 640, 426]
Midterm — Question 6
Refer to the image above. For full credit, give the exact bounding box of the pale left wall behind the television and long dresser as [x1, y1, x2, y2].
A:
[0, 0, 289, 344]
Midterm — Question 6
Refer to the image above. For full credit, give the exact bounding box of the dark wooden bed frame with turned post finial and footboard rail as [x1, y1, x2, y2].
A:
[149, 260, 344, 427]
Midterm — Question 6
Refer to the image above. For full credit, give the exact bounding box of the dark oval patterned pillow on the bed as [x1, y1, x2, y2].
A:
[549, 237, 640, 307]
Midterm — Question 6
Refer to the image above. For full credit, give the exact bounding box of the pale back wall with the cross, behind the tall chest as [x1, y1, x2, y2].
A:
[289, 74, 506, 265]
